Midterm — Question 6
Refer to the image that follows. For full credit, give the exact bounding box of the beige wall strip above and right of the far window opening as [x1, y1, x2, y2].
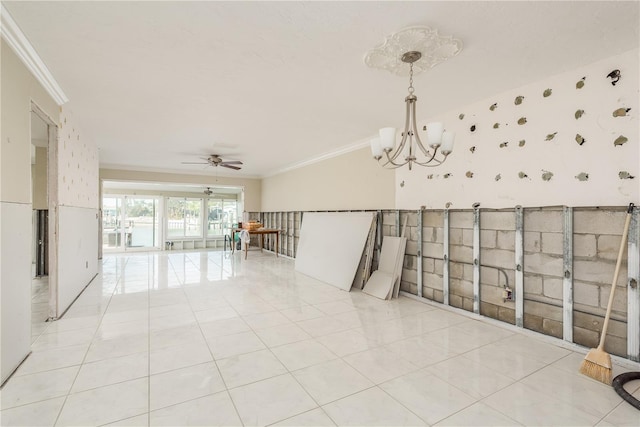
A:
[100, 169, 262, 212]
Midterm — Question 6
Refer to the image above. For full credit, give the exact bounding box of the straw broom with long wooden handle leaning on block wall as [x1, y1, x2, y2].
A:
[580, 203, 633, 385]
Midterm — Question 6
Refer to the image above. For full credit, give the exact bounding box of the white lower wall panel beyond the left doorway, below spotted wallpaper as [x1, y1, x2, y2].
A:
[57, 206, 98, 317]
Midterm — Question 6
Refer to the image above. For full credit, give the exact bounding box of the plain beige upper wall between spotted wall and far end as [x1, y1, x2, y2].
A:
[262, 148, 395, 212]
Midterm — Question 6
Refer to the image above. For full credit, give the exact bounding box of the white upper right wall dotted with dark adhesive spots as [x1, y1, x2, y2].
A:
[396, 50, 640, 209]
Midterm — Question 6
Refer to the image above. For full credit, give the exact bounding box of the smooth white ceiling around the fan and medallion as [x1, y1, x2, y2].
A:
[3, 1, 639, 176]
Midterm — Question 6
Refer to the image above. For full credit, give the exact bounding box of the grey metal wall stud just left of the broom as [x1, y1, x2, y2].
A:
[562, 206, 573, 342]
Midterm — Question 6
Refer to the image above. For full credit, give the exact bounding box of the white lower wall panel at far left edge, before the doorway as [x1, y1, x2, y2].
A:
[0, 202, 31, 382]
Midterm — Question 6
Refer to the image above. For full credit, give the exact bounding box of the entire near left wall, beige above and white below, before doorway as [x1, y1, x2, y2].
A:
[0, 39, 58, 382]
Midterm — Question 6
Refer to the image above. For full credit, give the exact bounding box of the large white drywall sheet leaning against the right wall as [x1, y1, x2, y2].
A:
[296, 212, 375, 291]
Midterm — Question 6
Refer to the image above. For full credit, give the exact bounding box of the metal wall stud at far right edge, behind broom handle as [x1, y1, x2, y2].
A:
[627, 206, 640, 362]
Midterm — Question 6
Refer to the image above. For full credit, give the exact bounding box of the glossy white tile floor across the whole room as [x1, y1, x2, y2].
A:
[0, 251, 640, 426]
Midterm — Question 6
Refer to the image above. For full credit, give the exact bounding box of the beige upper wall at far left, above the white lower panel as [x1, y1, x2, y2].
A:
[0, 40, 58, 203]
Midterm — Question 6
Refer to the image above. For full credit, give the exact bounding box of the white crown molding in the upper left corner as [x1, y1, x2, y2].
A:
[0, 4, 69, 105]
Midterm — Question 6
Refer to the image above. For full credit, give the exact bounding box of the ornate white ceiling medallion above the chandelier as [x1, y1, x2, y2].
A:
[364, 26, 462, 76]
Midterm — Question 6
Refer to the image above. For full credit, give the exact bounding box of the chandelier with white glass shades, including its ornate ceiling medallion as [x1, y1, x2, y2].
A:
[365, 27, 462, 170]
